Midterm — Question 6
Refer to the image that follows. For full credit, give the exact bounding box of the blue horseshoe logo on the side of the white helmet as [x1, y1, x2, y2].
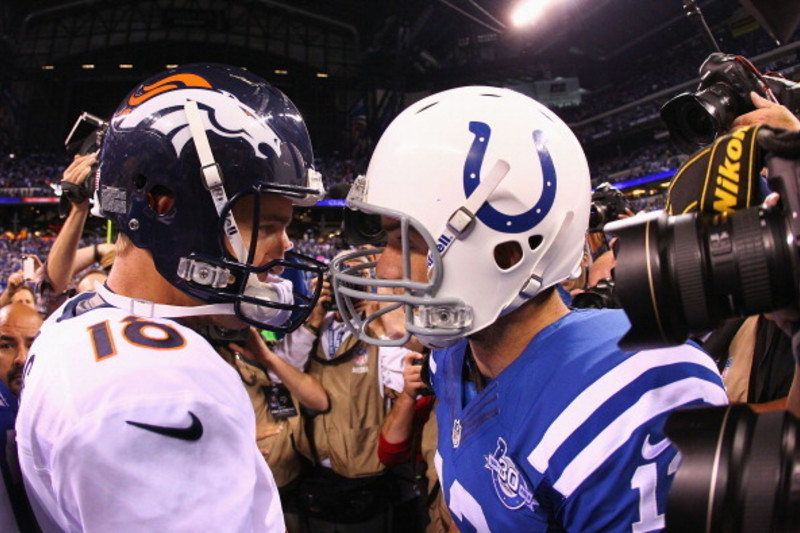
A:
[464, 122, 556, 233]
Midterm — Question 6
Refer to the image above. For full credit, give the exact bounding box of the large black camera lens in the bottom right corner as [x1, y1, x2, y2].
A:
[664, 404, 800, 533]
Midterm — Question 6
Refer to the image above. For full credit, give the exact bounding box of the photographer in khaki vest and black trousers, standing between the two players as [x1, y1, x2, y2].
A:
[282, 260, 405, 532]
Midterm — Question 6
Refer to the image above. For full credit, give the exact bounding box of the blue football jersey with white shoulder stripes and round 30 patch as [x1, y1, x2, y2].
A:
[431, 309, 727, 533]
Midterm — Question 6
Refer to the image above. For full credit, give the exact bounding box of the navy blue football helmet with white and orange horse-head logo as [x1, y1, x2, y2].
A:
[96, 64, 325, 332]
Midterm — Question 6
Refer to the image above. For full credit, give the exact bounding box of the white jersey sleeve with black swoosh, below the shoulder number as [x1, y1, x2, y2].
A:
[50, 394, 285, 532]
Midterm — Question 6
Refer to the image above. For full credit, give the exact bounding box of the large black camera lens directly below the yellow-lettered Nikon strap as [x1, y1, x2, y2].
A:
[604, 207, 798, 350]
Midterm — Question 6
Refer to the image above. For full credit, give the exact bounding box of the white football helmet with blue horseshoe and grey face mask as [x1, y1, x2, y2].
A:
[331, 87, 591, 347]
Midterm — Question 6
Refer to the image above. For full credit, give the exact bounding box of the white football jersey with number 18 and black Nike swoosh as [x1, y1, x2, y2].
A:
[17, 293, 285, 533]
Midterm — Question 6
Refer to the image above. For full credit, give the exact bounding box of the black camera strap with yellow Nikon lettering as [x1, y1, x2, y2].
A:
[666, 125, 764, 215]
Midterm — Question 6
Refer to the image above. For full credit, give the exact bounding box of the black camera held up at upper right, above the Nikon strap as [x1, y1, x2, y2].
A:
[661, 52, 800, 152]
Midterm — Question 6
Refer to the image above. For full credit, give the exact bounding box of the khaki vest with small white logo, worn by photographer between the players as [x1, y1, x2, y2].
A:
[297, 335, 386, 478]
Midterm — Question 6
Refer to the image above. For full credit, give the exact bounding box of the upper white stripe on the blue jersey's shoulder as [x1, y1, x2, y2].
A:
[528, 345, 721, 473]
